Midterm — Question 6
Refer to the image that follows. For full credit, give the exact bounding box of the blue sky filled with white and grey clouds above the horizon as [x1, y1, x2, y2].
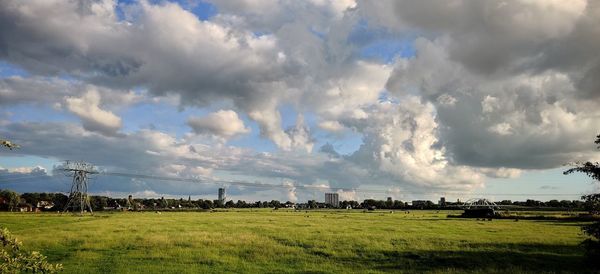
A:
[0, 0, 600, 202]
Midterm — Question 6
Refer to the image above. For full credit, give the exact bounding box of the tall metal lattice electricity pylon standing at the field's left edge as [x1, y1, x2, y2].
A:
[61, 161, 98, 214]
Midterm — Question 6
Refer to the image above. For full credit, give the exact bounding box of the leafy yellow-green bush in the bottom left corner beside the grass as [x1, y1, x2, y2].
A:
[0, 228, 62, 273]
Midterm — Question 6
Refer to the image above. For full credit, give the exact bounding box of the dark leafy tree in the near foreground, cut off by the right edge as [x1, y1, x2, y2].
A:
[564, 134, 600, 266]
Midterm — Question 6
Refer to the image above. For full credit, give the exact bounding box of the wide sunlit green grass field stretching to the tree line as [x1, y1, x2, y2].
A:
[0, 210, 589, 273]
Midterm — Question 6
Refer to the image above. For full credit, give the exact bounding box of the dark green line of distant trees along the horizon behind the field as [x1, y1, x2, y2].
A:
[0, 190, 589, 211]
